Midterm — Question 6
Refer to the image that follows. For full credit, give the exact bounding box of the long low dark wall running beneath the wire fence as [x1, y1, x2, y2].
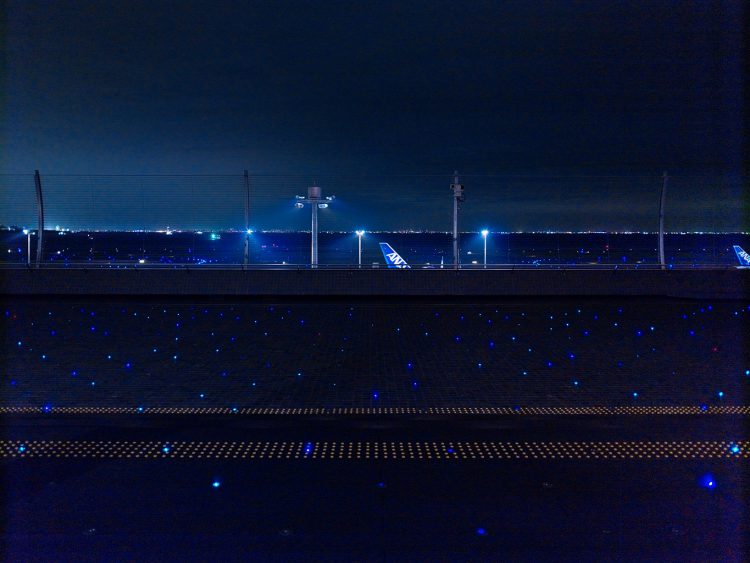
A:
[0, 269, 750, 299]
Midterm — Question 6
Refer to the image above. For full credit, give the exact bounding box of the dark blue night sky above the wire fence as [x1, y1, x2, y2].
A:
[0, 0, 744, 228]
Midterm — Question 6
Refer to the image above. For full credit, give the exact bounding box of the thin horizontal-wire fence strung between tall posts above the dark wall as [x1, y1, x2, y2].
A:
[0, 173, 750, 264]
